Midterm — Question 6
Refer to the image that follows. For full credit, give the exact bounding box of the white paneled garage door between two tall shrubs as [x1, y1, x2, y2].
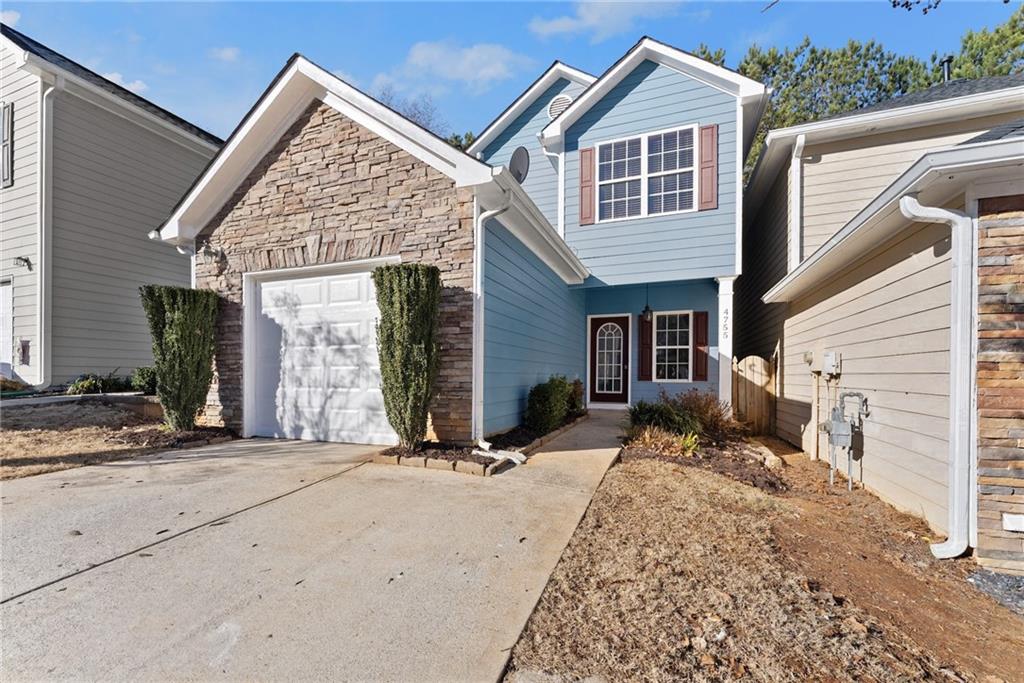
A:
[250, 272, 397, 444]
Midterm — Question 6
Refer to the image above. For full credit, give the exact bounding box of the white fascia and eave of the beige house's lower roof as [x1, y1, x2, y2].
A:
[761, 137, 1024, 303]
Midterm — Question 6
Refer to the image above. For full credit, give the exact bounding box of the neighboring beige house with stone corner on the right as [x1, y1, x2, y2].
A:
[735, 76, 1024, 571]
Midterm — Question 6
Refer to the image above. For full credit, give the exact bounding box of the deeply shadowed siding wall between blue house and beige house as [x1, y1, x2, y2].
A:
[733, 164, 790, 359]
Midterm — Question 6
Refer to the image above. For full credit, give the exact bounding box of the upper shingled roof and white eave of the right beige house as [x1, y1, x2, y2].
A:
[746, 75, 1024, 207]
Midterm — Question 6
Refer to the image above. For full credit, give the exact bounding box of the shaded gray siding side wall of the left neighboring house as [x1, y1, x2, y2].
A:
[51, 93, 212, 383]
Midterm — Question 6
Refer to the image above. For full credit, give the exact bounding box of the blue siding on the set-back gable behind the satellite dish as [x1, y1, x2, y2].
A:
[483, 78, 584, 227]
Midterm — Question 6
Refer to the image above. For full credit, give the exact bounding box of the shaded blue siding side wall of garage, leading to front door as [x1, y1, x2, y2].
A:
[483, 220, 587, 434]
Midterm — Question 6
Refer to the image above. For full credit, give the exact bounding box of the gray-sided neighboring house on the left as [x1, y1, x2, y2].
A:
[0, 26, 221, 388]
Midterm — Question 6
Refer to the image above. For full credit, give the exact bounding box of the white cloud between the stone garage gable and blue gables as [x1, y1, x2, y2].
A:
[373, 41, 534, 94]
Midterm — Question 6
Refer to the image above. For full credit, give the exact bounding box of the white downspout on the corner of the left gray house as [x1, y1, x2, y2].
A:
[32, 76, 63, 390]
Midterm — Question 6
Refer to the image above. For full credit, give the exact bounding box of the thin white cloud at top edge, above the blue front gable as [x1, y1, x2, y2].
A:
[529, 2, 679, 43]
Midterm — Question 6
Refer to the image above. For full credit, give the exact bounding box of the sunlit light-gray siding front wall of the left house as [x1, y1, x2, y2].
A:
[0, 43, 40, 384]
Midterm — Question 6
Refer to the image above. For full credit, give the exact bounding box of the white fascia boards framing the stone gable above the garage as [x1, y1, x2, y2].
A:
[160, 56, 492, 244]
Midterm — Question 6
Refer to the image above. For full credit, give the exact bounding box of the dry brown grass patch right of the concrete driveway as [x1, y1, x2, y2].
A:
[510, 460, 1024, 681]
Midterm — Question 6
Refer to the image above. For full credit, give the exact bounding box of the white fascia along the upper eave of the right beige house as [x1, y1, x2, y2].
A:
[746, 86, 1024, 205]
